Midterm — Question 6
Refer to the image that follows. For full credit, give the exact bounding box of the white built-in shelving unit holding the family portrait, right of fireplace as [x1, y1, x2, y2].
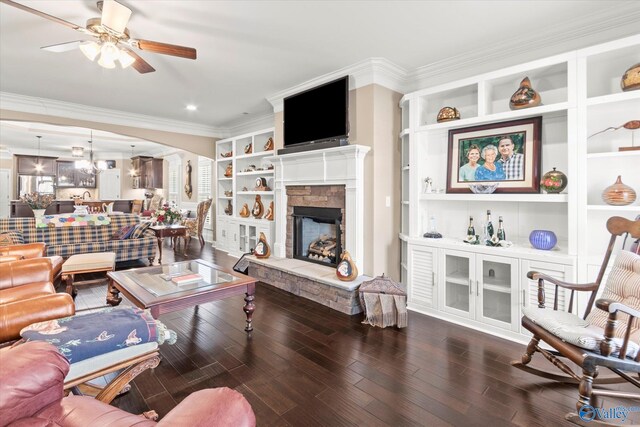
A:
[399, 35, 640, 341]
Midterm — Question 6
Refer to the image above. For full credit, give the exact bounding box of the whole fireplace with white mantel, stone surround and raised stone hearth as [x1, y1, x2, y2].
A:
[249, 145, 370, 315]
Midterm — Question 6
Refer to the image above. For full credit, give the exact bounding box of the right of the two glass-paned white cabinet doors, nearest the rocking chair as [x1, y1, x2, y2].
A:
[475, 254, 520, 332]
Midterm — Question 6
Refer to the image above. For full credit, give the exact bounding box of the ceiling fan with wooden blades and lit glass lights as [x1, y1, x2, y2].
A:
[0, 0, 196, 74]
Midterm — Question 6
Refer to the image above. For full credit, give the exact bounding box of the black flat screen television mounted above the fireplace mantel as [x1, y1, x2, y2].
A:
[284, 76, 349, 148]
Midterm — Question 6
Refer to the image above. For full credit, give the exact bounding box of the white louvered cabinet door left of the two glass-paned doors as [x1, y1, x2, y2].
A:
[407, 245, 437, 309]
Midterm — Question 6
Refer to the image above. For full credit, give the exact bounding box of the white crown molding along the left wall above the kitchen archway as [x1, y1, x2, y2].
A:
[0, 92, 223, 137]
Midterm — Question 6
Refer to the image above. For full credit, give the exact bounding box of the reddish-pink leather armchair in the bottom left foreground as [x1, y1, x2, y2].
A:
[0, 341, 256, 427]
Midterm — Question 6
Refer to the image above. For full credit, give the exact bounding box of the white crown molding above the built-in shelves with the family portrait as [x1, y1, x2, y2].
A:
[403, 1, 640, 93]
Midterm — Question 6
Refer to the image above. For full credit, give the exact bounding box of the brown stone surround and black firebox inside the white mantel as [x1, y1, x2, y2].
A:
[286, 185, 345, 268]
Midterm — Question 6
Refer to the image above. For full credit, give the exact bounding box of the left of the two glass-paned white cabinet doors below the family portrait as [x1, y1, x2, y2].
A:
[441, 251, 475, 318]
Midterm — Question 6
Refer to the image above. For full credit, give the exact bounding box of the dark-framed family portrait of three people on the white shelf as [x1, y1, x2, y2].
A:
[447, 116, 542, 193]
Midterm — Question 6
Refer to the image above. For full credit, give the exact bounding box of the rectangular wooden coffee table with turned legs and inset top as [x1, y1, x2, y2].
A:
[107, 259, 256, 332]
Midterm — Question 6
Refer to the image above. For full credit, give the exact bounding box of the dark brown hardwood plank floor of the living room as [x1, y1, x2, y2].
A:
[72, 240, 638, 426]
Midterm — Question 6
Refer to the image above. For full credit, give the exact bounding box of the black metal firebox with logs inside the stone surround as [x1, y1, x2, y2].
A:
[293, 206, 342, 267]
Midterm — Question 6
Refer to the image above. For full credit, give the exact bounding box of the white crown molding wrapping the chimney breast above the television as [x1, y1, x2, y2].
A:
[267, 58, 407, 113]
